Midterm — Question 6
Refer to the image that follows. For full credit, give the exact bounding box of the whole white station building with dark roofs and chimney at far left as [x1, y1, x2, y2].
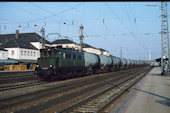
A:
[0, 30, 51, 61]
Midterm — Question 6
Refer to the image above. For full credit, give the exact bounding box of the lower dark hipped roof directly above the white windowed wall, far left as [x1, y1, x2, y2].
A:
[0, 38, 38, 50]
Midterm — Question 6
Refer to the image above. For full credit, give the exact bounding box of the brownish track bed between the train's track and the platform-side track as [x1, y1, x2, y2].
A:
[0, 66, 150, 111]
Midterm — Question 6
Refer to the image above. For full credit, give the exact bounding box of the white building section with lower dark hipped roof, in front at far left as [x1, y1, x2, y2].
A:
[0, 38, 40, 61]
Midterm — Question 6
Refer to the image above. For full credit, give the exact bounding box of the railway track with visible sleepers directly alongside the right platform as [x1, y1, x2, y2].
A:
[57, 67, 149, 113]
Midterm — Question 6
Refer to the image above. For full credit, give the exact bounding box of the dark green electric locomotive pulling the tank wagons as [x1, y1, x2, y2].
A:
[36, 48, 85, 79]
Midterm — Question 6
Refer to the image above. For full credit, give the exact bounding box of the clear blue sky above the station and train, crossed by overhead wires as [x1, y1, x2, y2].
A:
[0, 2, 170, 60]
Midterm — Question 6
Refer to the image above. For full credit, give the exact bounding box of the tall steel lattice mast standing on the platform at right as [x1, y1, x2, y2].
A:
[161, 1, 170, 75]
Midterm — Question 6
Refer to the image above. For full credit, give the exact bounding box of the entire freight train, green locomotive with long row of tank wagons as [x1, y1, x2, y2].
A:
[35, 47, 148, 80]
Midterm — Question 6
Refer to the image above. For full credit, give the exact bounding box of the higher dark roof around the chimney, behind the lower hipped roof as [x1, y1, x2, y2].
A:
[0, 33, 51, 44]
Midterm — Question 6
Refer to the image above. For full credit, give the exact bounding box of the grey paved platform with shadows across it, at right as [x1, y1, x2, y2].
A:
[109, 67, 170, 113]
